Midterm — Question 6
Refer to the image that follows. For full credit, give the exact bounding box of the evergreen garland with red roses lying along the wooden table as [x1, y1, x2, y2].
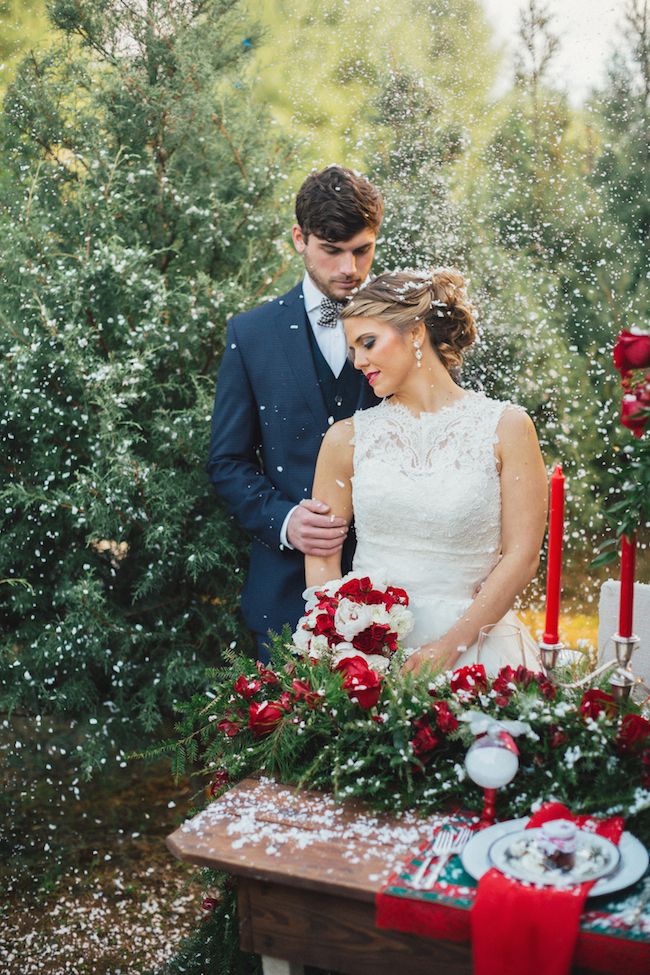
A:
[166, 637, 650, 839]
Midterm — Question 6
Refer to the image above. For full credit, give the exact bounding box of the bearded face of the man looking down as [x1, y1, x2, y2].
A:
[292, 224, 377, 301]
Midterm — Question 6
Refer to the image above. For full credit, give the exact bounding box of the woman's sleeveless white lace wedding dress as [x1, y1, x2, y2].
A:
[352, 392, 540, 673]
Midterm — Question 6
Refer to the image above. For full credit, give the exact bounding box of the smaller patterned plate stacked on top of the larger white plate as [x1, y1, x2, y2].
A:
[488, 829, 621, 887]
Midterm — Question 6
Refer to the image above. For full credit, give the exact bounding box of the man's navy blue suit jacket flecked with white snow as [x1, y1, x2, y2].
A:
[208, 284, 378, 633]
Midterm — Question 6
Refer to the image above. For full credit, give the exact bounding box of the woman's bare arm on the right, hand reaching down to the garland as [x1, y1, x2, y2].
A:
[400, 410, 547, 672]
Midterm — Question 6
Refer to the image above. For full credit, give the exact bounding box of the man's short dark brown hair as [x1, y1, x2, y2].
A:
[296, 166, 384, 241]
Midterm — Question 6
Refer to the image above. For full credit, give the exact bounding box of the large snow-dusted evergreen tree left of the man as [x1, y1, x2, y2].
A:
[0, 0, 287, 764]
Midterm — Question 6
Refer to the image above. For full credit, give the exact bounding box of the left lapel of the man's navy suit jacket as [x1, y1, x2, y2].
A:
[278, 284, 327, 430]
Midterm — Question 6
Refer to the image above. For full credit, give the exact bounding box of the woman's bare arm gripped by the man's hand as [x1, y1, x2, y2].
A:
[305, 420, 354, 586]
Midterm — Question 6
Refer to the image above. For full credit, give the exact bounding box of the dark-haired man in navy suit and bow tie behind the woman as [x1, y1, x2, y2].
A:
[208, 166, 383, 660]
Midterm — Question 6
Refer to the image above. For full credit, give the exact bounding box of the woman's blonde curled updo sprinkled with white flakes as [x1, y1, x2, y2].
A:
[341, 268, 477, 369]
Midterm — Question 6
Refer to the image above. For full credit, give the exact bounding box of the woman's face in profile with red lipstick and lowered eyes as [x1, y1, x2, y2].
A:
[345, 318, 416, 396]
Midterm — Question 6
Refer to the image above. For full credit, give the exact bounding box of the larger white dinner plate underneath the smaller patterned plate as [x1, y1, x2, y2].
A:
[460, 816, 649, 897]
